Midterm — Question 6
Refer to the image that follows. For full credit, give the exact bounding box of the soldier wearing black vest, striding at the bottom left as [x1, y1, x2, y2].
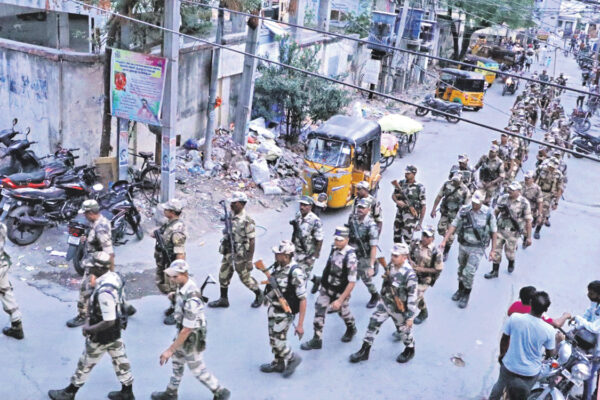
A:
[48, 251, 135, 400]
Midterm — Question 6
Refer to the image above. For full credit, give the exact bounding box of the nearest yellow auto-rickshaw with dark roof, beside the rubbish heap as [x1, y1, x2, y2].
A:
[302, 115, 381, 208]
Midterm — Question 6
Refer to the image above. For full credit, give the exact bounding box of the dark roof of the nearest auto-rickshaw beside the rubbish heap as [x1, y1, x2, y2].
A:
[307, 115, 381, 145]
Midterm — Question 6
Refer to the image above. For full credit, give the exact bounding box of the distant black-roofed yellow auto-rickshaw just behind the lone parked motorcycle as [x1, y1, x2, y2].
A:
[435, 68, 485, 111]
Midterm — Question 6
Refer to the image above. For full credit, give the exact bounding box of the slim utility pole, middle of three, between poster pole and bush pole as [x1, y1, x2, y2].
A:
[202, 3, 225, 170]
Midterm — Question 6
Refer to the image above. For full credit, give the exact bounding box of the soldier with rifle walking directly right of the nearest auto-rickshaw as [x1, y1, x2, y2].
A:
[392, 165, 427, 243]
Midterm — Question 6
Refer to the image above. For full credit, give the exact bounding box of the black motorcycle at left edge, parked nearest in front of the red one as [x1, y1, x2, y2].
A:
[0, 167, 102, 246]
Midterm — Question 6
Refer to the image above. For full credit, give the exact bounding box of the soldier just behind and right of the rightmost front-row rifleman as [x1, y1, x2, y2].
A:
[409, 226, 444, 325]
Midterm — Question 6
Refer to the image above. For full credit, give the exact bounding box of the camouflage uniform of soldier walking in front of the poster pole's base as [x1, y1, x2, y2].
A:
[154, 218, 187, 294]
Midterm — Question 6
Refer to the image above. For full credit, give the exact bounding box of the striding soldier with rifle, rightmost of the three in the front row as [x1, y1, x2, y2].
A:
[350, 243, 418, 363]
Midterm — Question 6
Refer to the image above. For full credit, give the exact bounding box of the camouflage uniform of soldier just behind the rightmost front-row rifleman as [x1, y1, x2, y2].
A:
[409, 240, 444, 310]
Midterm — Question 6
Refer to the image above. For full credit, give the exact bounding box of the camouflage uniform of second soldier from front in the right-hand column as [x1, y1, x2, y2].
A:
[492, 194, 533, 264]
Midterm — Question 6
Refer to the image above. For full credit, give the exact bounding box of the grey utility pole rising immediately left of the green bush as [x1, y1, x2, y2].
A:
[233, 16, 260, 146]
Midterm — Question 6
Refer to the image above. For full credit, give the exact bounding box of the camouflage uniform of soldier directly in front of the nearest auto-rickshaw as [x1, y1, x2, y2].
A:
[292, 211, 323, 277]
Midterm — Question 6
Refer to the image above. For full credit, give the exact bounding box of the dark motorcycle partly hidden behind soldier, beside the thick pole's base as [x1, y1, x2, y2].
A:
[67, 181, 144, 275]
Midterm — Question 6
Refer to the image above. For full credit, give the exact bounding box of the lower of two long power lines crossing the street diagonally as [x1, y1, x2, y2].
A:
[63, 0, 600, 162]
